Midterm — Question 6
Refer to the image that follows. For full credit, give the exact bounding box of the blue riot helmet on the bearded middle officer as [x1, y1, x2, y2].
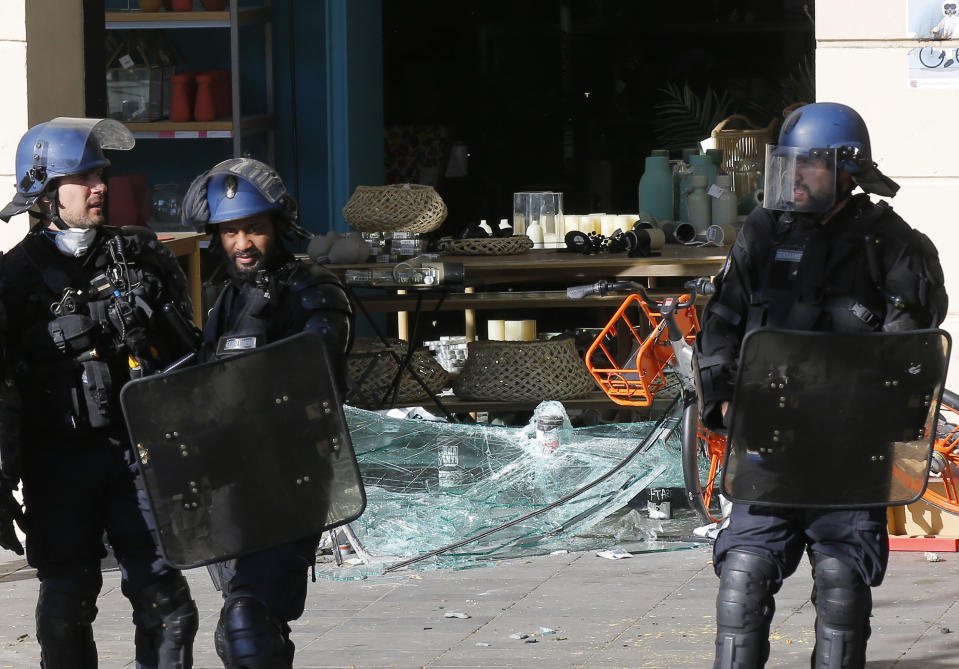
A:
[182, 158, 312, 239]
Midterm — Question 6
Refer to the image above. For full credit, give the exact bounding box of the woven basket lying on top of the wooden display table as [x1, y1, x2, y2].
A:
[343, 184, 447, 232]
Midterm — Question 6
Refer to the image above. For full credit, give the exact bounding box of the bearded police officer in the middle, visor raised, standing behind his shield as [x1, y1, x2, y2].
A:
[183, 158, 353, 668]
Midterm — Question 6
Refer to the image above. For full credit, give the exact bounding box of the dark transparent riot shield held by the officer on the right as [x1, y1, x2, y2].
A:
[723, 330, 951, 508]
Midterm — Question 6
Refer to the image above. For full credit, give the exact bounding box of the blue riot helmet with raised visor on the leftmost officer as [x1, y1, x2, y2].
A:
[0, 116, 135, 221]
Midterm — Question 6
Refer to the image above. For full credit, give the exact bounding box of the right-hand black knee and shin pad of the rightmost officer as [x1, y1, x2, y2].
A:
[812, 553, 872, 669]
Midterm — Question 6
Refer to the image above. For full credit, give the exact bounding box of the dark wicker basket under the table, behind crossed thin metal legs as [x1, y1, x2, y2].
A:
[346, 339, 449, 408]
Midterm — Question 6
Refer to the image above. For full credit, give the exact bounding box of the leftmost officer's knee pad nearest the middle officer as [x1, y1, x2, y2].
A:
[130, 572, 199, 669]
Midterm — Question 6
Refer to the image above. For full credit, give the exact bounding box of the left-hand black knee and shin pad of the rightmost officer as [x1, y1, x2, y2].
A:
[713, 550, 778, 669]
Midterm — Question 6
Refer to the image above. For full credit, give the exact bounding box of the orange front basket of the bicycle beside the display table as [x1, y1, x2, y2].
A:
[586, 294, 700, 407]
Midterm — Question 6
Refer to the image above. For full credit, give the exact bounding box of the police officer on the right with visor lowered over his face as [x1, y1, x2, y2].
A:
[696, 103, 947, 669]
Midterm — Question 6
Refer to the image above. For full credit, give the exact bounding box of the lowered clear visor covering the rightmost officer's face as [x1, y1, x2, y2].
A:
[763, 144, 836, 212]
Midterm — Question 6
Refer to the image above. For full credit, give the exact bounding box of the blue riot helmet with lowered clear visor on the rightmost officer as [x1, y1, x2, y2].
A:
[763, 102, 899, 212]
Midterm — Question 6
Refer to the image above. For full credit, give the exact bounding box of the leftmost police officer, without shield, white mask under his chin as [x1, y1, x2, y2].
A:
[0, 118, 197, 669]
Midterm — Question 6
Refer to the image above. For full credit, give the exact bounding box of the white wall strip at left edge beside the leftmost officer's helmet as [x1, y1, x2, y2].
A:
[0, 0, 29, 251]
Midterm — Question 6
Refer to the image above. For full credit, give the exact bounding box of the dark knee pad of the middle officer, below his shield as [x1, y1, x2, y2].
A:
[214, 595, 293, 669]
